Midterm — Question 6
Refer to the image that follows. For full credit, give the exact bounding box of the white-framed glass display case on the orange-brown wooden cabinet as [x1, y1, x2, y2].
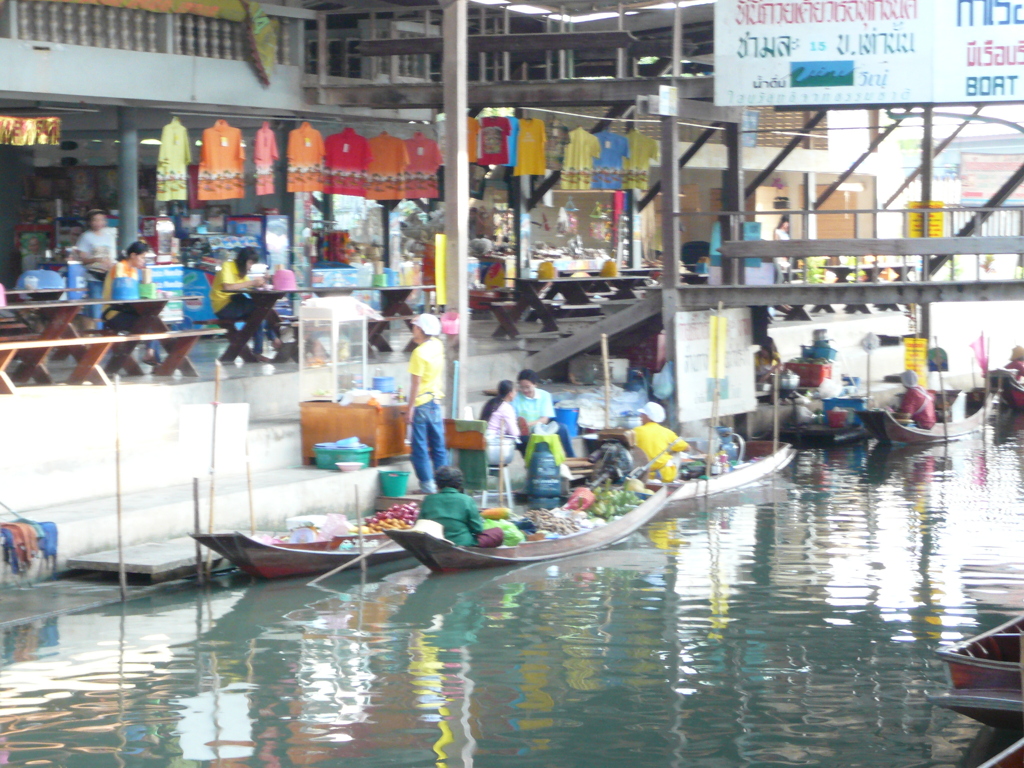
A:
[299, 306, 368, 402]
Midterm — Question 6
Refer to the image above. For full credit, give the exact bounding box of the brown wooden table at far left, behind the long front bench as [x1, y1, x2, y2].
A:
[6, 299, 166, 384]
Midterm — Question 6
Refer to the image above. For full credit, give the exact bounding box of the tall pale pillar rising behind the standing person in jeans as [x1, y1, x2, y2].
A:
[441, 0, 469, 416]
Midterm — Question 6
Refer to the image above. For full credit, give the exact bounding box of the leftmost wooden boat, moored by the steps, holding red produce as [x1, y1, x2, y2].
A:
[193, 531, 409, 579]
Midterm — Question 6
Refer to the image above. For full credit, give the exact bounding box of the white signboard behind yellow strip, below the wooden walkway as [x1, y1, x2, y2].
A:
[676, 309, 758, 422]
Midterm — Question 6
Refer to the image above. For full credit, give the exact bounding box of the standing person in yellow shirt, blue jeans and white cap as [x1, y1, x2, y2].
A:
[406, 314, 447, 494]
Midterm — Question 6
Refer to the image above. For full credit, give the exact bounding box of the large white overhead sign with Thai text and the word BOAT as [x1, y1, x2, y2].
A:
[715, 0, 1024, 106]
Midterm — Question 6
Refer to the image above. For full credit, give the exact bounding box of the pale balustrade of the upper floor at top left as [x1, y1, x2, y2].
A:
[0, 0, 297, 65]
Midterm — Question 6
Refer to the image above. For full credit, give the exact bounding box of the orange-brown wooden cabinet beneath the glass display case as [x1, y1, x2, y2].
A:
[299, 401, 410, 466]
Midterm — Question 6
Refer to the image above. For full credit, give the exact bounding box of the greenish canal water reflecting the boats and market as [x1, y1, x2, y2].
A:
[6, 425, 1024, 768]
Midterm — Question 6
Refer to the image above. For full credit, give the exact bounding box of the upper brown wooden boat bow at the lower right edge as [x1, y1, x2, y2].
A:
[937, 615, 1024, 691]
